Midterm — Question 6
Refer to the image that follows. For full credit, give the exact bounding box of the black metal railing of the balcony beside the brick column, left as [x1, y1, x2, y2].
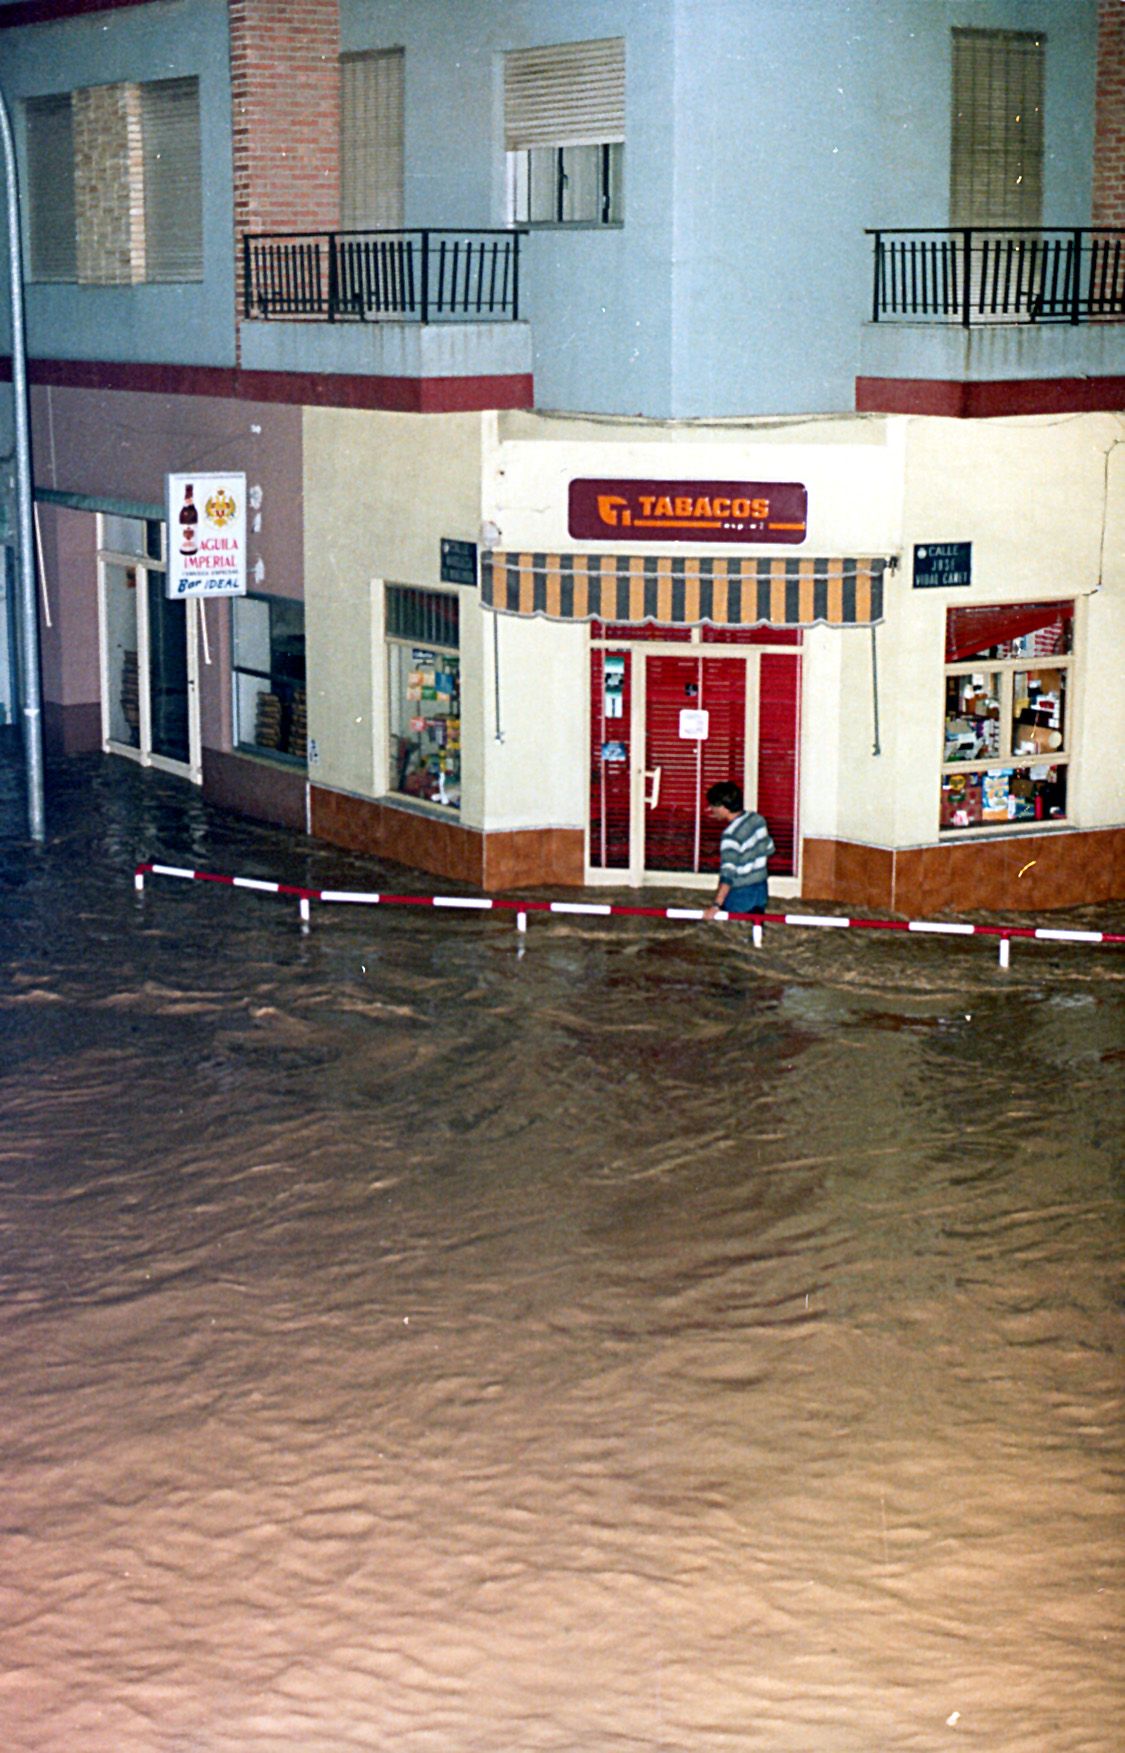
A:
[242, 230, 524, 323]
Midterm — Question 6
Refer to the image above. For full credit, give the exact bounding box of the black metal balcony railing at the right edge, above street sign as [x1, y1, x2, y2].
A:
[867, 226, 1125, 328]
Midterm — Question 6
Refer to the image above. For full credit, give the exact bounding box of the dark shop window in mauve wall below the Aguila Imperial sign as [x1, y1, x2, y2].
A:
[231, 596, 308, 764]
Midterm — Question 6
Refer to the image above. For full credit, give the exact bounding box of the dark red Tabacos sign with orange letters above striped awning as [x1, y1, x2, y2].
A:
[568, 480, 808, 545]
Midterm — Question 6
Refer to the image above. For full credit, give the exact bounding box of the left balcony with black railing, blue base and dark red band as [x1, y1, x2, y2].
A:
[240, 230, 531, 407]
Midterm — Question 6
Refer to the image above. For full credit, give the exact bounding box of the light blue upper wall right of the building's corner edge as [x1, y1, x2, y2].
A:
[673, 0, 1097, 415]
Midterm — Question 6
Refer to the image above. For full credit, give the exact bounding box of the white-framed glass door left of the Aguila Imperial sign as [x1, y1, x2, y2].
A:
[98, 515, 202, 784]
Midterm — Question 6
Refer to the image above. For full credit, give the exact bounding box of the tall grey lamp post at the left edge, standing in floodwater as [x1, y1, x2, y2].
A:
[0, 91, 46, 840]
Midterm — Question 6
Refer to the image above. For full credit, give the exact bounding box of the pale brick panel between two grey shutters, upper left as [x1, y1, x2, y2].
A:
[72, 86, 145, 286]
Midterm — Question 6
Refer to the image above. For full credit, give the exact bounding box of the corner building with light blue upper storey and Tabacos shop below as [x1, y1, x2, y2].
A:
[0, 0, 1125, 912]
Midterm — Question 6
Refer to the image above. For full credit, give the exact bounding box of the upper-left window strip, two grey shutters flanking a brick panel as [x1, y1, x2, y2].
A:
[25, 79, 203, 286]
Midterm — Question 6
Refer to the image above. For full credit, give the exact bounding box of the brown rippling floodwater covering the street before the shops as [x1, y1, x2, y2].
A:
[0, 745, 1125, 1753]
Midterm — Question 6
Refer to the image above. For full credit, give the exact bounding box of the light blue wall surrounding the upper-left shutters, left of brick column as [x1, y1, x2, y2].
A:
[0, 0, 235, 365]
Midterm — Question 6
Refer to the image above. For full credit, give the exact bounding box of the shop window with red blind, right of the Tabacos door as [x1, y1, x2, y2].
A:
[941, 601, 1074, 831]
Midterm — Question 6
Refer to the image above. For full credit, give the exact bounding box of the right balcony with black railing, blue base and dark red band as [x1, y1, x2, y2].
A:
[857, 226, 1125, 412]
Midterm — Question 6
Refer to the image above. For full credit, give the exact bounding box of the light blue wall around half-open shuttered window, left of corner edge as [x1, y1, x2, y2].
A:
[340, 0, 675, 414]
